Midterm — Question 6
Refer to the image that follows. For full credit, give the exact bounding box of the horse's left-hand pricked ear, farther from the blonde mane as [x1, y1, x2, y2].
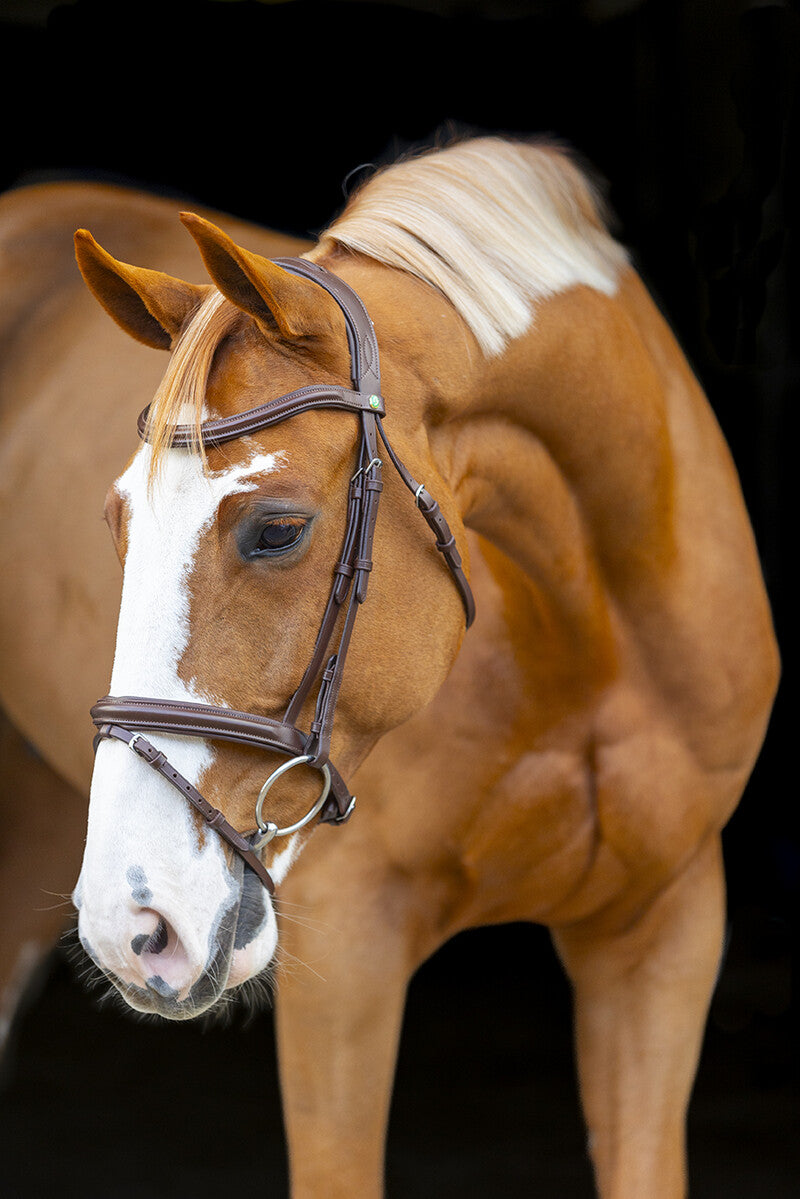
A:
[74, 229, 209, 350]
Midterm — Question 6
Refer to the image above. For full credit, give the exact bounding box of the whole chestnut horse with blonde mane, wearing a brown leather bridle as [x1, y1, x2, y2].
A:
[0, 137, 780, 1199]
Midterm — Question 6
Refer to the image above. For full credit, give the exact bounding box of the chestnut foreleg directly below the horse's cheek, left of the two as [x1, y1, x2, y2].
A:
[277, 853, 414, 1199]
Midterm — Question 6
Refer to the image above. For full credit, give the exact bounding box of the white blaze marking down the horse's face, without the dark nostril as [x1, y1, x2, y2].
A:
[76, 445, 288, 993]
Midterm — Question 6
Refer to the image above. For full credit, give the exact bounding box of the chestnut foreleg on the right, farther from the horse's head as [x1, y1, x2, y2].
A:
[553, 838, 724, 1199]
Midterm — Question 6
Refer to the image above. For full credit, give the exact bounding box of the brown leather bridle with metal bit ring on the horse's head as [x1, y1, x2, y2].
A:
[91, 258, 475, 893]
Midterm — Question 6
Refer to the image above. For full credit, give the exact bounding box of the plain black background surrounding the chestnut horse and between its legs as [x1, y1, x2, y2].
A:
[0, 0, 800, 1199]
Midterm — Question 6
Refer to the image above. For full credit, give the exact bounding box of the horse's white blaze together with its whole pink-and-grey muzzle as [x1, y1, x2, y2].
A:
[73, 445, 287, 1019]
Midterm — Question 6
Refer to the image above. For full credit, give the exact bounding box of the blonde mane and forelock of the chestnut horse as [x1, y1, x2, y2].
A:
[148, 137, 627, 477]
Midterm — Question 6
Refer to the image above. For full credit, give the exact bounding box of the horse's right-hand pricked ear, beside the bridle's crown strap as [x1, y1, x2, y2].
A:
[181, 212, 335, 339]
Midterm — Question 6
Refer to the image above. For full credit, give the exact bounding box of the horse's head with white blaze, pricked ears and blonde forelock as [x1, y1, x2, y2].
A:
[74, 215, 469, 1019]
